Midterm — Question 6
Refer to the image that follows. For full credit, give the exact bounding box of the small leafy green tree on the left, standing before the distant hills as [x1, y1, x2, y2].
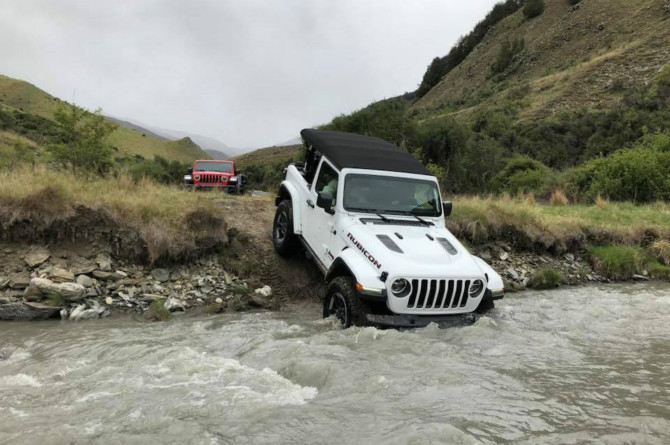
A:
[47, 105, 117, 173]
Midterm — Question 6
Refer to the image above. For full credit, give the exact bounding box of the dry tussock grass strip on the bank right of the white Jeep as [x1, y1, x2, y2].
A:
[447, 195, 670, 253]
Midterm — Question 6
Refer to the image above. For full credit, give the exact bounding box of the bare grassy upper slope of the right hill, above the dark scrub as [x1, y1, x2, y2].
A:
[410, 0, 670, 121]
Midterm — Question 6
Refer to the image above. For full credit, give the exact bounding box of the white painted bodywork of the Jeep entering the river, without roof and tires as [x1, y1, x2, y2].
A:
[282, 163, 503, 315]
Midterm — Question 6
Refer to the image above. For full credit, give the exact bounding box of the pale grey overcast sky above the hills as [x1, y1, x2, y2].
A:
[0, 0, 496, 147]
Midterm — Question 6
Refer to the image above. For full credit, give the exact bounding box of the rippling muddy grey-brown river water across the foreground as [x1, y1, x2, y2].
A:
[0, 284, 670, 444]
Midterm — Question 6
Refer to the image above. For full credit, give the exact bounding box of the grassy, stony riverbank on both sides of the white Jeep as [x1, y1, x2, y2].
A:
[0, 169, 670, 320]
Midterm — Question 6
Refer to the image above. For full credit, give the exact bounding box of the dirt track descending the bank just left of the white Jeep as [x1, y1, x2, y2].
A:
[220, 197, 325, 301]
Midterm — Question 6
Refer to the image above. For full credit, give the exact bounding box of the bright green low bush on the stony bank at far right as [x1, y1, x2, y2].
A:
[591, 246, 645, 280]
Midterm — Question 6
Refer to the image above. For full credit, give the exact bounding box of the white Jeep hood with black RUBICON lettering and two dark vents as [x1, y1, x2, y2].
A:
[342, 222, 484, 277]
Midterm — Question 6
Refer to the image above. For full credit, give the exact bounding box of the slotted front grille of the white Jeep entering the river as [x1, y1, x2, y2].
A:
[407, 279, 471, 309]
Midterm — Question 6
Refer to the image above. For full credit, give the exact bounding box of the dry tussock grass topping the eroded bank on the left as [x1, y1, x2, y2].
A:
[0, 167, 228, 263]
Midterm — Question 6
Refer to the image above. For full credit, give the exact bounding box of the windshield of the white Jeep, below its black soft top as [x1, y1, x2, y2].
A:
[342, 174, 442, 216]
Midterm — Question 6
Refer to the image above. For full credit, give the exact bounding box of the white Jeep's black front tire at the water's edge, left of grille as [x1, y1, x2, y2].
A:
[323, 277, 370, 329]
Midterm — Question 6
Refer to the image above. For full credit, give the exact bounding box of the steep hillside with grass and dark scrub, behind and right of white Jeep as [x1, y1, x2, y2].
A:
[314, 0, 670, 201]
